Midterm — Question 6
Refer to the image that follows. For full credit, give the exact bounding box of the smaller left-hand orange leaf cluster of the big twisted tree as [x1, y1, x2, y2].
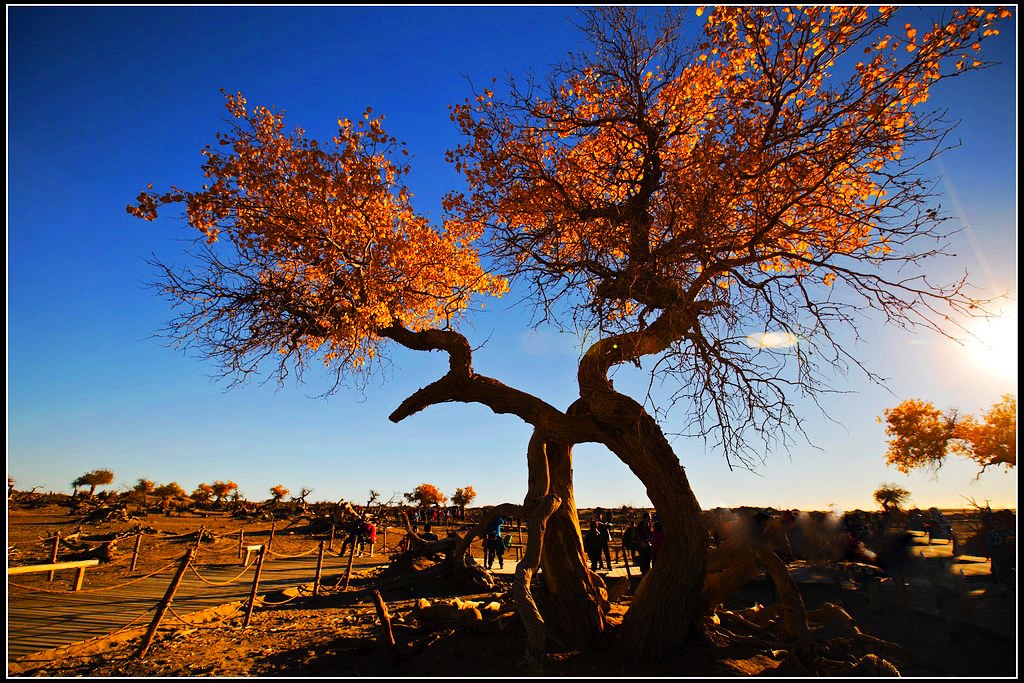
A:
[128, 94, 506, 374]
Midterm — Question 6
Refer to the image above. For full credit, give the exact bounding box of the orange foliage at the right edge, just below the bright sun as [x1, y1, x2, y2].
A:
[879, 394, 1017, 476]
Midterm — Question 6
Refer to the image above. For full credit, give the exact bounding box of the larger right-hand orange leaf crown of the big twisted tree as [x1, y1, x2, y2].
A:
[446, 6, 1010, 315]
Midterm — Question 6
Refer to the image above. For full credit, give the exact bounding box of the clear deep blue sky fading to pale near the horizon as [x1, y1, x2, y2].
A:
[7, 7, 1017, 509]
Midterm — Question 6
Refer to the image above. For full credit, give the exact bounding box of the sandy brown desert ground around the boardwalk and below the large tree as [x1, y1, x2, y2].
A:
[7, 506, 1017, 678]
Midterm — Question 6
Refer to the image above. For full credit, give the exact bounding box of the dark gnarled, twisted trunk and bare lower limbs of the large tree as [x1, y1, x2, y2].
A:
[380, 325, 708, 659]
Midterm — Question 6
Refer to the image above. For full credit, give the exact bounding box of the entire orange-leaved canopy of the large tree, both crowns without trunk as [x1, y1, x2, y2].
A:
[128, 6, 1010, 414]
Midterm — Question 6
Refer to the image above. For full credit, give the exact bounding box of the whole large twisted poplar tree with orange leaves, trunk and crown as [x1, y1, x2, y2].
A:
[129, 6, 1009, 658]
